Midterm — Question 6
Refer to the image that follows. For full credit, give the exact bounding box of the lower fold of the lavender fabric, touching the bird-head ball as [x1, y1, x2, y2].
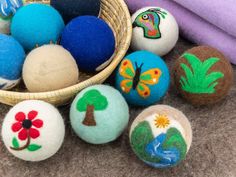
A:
[126, 0, 236, 64]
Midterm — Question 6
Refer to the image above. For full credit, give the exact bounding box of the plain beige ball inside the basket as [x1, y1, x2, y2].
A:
[23, 44, 79, 92]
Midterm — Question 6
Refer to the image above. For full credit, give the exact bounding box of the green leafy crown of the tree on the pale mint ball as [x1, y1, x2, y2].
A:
[77, 89, 108, 112]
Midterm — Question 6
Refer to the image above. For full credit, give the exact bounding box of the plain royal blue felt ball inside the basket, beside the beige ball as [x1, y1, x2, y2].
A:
[61, 16, 115, 72]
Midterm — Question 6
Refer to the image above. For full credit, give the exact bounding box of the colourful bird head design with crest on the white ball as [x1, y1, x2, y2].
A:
[133, 8, 167, 39]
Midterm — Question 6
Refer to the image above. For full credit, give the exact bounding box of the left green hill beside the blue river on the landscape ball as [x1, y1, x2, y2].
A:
[131, 121, 160, 163]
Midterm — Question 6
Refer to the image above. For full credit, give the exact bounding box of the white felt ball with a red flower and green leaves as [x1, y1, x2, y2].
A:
[2, 100, 65, 161]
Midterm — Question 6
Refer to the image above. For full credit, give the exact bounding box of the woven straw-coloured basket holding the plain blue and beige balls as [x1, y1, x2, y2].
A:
[0, 0, 132, 106]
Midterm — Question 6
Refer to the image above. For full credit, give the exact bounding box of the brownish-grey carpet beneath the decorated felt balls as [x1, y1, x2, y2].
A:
[0, 40, 236, 177]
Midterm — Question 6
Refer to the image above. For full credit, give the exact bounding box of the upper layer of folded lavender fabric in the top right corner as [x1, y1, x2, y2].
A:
[174, 0, 236, 37]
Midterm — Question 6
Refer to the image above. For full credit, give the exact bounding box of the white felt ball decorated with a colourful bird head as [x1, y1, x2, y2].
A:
[131, 7, 179, 56]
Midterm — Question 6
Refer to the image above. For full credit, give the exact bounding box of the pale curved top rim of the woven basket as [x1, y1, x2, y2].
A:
[0, 0, 132, 99]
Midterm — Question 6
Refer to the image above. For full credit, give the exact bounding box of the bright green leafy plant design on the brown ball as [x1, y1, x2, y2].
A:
[180, 53, 224, 94]
